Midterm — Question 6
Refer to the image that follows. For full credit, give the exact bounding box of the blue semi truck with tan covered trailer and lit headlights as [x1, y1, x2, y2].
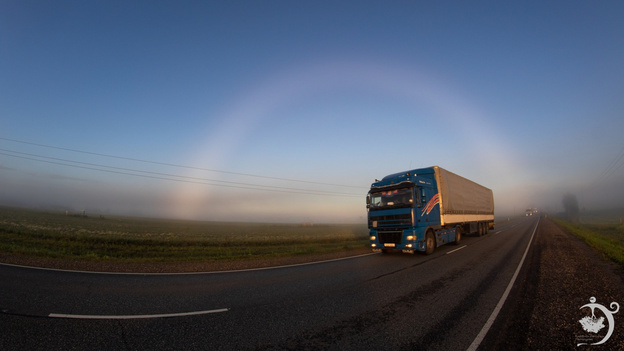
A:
[366, 166, 494, 255]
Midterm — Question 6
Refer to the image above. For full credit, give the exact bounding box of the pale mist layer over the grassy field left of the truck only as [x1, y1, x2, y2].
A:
[0, 169, 366, 223]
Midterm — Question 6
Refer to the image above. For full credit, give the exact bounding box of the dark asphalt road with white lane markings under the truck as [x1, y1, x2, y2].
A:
[0, 216, 538, 350]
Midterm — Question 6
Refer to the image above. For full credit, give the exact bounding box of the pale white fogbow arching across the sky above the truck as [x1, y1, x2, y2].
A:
[166, 60, 515, 218]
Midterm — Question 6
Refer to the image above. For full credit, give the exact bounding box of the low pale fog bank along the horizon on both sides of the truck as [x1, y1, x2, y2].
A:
[0, 158, 624, 224]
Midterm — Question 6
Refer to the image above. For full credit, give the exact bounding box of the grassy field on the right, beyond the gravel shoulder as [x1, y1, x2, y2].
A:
[553, 211, 624, 267]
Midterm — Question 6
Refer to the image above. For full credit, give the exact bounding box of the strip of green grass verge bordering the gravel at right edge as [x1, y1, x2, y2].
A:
[551, 217, 624, 268]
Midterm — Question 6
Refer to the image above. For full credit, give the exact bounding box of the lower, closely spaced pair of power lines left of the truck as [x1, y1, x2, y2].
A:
[0, 148, 360, 197]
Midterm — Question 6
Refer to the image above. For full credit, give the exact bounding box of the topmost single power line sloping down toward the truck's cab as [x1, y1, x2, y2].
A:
[0, 137, 364, 189]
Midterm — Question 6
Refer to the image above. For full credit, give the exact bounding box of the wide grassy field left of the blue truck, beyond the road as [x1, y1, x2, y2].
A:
[0, 207, 368, 262]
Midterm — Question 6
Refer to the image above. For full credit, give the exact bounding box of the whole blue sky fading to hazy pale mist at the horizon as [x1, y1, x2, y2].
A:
[0, 0, 624, 223]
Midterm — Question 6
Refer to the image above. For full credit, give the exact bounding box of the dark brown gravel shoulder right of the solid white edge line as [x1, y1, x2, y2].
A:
[480, 218, 624, 350]
